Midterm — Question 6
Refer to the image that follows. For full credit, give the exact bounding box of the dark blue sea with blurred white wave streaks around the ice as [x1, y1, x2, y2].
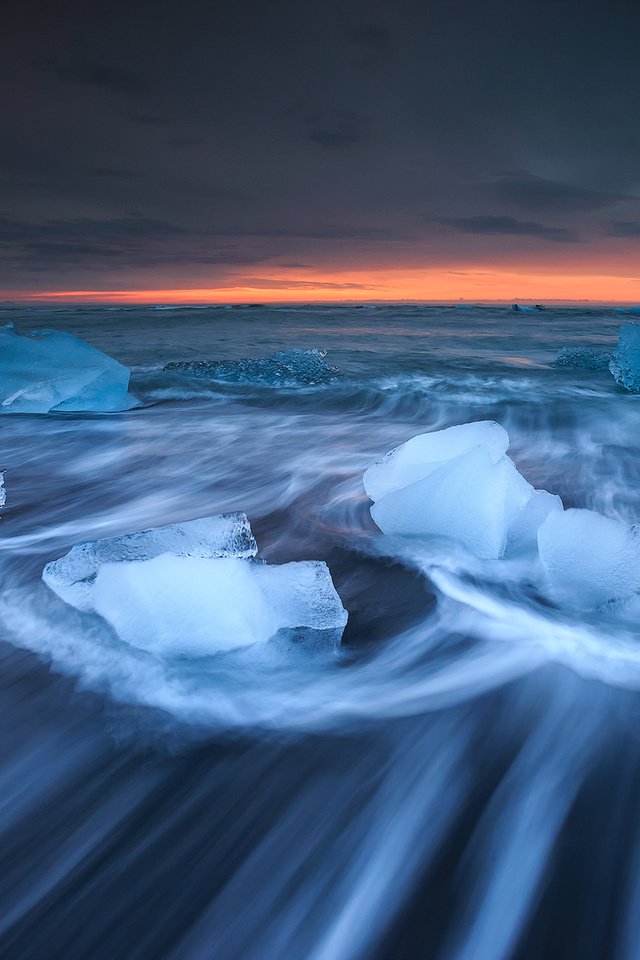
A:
[0, 305, 640, 960]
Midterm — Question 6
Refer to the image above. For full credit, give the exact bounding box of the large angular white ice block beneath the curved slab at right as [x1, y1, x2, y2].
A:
[371, 446, 533, 559]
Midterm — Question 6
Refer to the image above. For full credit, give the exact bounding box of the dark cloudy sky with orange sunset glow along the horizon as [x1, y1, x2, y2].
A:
[0, 0, 640, 302]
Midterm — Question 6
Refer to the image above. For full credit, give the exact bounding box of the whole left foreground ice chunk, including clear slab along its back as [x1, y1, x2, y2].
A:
[43, 513, 347, 657]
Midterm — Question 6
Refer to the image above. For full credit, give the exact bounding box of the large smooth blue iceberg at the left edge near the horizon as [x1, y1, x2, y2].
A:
[0, 326, 135, 413]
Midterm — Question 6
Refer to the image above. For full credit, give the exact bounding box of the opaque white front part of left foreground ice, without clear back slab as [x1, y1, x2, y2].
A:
[94, 554, 347, 657]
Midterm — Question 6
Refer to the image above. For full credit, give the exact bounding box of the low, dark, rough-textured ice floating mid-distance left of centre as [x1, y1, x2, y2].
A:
[164, 348, 341, 386]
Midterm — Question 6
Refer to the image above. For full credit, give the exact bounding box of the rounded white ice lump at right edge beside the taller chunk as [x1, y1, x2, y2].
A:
[538, 510, 640, 607]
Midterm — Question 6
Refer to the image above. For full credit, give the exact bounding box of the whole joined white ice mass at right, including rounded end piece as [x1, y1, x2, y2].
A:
[365, 421, 640, 609]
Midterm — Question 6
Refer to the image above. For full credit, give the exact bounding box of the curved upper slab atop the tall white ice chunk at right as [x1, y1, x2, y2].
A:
[363, 420, 509, 500]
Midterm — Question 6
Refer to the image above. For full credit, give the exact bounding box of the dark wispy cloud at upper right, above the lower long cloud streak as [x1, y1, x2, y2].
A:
[489, 176, 640, 213]
